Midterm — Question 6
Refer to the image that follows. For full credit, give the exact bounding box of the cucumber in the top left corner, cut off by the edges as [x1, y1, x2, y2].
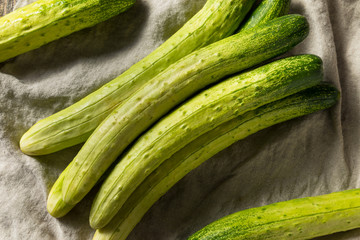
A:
[0, 0, 135, 62]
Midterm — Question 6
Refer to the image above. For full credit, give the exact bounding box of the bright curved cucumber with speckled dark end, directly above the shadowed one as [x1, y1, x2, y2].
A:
[89, 55, 322, 229]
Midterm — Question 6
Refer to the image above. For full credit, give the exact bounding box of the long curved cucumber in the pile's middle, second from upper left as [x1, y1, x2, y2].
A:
[63, 15, 309, 208]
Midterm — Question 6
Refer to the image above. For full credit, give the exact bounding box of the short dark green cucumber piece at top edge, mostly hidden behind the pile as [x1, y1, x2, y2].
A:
[240, 0, 291, 32]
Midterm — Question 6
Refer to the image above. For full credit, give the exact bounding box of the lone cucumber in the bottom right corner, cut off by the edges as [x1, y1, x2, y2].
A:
[189, 189, 360, 240]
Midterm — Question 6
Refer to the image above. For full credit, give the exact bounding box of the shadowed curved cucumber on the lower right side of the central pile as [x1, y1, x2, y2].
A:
[93, 85, 338, 240]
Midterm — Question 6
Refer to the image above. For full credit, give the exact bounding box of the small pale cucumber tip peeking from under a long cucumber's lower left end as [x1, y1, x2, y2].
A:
[46, 163, 75, 218]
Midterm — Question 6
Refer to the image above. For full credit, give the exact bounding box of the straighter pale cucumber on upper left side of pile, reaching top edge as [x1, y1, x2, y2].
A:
[20, 0, 255, 155]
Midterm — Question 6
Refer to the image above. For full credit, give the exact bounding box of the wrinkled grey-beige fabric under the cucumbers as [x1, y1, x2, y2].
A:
[0, 0, 360, 240]
